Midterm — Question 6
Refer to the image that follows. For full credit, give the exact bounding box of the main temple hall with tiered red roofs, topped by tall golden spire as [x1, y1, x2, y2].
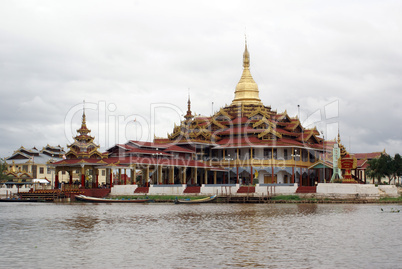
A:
[154, 43, 335, 186]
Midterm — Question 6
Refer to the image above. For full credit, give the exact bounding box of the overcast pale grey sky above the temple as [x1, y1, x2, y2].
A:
[0, 0, 402, 157]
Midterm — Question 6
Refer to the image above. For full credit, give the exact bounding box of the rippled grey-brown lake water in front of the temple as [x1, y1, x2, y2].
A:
[0, 203, 402, 268]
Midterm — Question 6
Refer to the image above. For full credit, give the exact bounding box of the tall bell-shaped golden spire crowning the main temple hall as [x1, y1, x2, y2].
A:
[232, 40, 262, 105]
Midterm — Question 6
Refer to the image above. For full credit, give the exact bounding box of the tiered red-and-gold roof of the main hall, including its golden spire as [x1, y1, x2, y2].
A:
[154, 43, 326, 149]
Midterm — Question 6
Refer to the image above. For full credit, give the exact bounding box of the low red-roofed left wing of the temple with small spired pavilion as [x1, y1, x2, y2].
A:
[52, 105, 218, 189]
